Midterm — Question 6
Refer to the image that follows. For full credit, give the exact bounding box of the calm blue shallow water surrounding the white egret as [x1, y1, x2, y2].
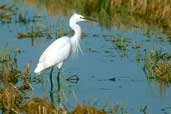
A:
[0, 1, 171, 114]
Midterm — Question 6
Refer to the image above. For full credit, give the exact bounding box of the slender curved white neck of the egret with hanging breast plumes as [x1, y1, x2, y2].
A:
[70, 23, 81, 56]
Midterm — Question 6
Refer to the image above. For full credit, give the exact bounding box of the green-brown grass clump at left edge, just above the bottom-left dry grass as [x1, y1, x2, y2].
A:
[0, 49, 21, 84]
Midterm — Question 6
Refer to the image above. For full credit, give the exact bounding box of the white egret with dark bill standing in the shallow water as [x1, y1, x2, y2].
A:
[34, 13, 95, 92]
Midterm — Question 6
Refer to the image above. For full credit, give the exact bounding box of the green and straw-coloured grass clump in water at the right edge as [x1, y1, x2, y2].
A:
[144, 50, 171, 83]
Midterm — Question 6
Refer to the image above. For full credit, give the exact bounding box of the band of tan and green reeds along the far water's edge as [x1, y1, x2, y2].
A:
[24, 0, 171, 29]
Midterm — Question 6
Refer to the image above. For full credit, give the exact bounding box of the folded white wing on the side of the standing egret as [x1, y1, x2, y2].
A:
[39, 37, 71, 67]
